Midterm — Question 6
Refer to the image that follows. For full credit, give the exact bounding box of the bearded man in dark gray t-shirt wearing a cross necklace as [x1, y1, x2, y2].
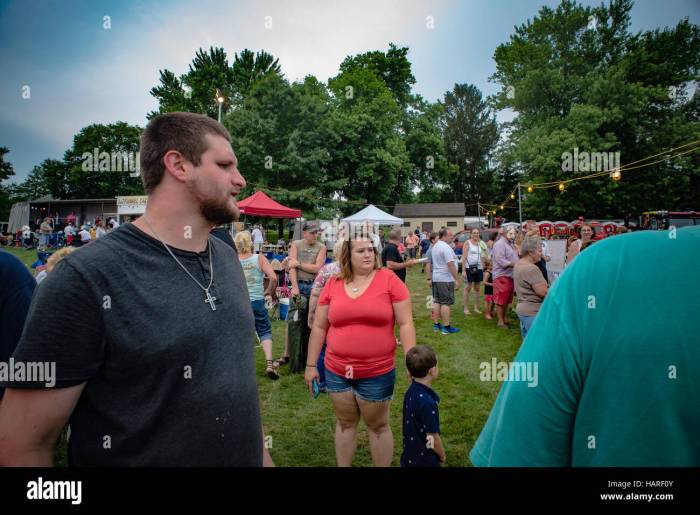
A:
[0, 113, 271, 466]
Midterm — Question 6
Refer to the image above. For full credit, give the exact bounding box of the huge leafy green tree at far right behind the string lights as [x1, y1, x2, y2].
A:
[492, 0, 700, 218]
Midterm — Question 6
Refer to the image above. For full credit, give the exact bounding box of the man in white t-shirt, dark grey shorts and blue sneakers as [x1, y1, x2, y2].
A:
[430, 228, 459, 334]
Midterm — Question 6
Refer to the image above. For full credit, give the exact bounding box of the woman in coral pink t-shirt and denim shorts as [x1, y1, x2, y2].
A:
[305, 238, 416, 467]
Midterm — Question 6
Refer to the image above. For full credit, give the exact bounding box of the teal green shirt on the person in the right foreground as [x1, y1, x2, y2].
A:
[470, 227, 700, 467]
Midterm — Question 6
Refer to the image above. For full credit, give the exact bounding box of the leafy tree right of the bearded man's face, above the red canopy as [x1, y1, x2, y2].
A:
[224, 74, 335, 216]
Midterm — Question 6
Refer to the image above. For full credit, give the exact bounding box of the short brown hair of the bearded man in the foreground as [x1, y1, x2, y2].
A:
[140, 113, 231, 194]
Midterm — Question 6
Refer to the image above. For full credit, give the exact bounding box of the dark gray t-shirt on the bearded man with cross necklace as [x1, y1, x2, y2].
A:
[5, 224, 262, 466]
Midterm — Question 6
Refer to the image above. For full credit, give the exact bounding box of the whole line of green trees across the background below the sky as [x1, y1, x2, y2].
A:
[0, 0, 700, 219]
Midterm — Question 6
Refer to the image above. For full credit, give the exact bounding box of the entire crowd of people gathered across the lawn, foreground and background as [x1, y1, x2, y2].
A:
[0, 113, 700, 467]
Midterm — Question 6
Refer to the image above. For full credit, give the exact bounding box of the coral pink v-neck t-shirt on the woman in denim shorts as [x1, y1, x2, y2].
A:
[318, 268, 409, 379]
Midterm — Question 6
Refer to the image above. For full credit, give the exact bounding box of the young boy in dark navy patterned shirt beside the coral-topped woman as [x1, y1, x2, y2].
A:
[401, 345, 445, 467]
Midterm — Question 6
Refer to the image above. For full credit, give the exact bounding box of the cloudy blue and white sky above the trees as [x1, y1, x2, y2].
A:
[0, 0, 700, 182]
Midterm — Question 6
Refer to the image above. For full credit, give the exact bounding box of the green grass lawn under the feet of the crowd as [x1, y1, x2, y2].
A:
[4, 249, 520, 467]
